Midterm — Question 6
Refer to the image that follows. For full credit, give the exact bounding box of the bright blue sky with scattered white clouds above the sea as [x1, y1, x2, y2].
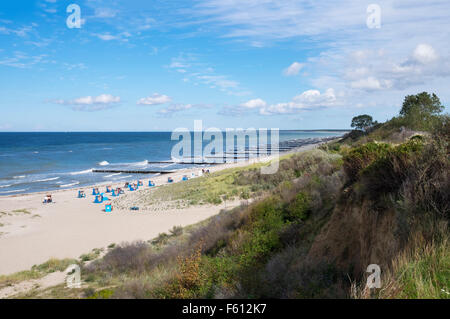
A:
[0, 0, 450, 131]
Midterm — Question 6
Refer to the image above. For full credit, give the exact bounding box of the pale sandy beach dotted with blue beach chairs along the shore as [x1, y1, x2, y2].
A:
[0, 144, 320, 275]
